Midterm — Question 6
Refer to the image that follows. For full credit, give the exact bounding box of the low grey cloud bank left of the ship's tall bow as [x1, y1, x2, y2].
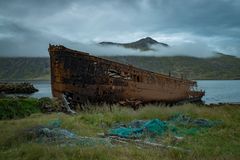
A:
[0, 19, 72, 57]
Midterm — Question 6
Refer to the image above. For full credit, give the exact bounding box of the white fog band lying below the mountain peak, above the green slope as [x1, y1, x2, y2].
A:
[62, 42, 215, 57]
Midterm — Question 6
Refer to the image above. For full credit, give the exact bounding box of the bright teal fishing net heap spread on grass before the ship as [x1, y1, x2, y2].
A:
[108, 114, 220, 138]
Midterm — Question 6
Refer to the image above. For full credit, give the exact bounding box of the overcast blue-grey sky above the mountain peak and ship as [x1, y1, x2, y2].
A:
[0, 0, 240, 56]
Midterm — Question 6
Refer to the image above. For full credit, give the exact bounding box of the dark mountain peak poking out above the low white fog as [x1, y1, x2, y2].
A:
[99, 37, 169, 51]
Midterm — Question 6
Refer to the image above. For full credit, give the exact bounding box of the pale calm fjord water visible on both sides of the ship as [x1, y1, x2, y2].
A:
[31, 80, 240, 104]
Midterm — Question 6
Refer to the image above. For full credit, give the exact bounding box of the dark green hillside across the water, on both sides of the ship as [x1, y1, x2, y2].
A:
[0, 55, 240, 80]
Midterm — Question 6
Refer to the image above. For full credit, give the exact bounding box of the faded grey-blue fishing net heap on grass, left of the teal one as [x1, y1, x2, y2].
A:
[24, 119, 111, 146]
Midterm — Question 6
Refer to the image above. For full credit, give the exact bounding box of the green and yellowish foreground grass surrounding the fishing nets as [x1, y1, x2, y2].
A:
[0, 104, 240, 160]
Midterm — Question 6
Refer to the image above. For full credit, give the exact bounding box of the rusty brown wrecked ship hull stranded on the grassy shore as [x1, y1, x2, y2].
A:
[48, 45, 204, 104]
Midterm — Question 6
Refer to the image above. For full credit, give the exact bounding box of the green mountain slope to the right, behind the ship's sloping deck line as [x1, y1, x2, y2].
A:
[107, 55, 240, 79]
